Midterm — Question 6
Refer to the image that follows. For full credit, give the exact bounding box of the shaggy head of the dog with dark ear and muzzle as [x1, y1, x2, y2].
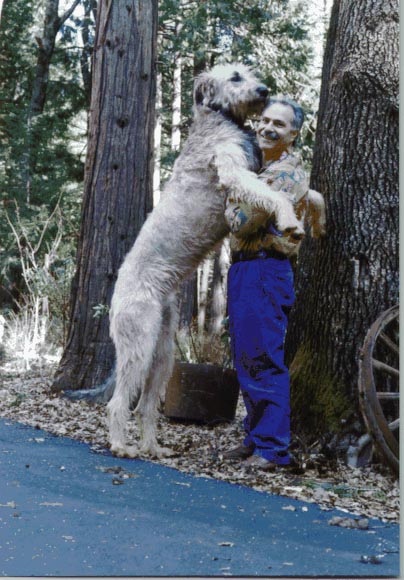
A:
[194, 63, 268, 125]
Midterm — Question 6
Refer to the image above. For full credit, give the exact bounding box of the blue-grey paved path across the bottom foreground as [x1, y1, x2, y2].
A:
[0, 419, 399, 577]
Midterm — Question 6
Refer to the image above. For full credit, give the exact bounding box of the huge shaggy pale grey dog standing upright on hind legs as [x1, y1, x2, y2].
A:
[108, 64, 302, 457]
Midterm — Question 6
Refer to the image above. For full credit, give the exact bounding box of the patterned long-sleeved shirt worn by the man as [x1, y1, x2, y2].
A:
[225, 151, 309, 257]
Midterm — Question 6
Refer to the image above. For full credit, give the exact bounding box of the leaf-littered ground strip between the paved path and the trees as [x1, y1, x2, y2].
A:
[0, 363, 400, 525]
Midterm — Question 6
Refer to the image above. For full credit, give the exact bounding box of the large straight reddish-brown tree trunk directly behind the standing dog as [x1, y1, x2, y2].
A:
[54, 0, 157, 390]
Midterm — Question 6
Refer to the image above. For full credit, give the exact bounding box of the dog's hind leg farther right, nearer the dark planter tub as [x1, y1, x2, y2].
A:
[136, 295, 178, 458]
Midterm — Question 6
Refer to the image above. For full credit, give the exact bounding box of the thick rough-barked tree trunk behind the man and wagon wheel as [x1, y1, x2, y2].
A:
[286, 0, 399, 433]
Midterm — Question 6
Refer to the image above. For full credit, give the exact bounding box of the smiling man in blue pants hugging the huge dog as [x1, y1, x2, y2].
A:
[224, 97, 324, 471]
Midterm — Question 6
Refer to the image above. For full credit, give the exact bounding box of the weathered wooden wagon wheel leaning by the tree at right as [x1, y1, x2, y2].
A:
[359, 305, 400, 474]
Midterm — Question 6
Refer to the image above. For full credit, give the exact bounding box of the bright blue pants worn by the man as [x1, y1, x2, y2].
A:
[228, 258, 295, 465]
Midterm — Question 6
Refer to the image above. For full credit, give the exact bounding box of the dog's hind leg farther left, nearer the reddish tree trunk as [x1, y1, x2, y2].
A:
[107, 301, 162, 457]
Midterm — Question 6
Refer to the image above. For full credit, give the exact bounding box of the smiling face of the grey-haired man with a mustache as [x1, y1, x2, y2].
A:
[257, 103, 298, 161]
